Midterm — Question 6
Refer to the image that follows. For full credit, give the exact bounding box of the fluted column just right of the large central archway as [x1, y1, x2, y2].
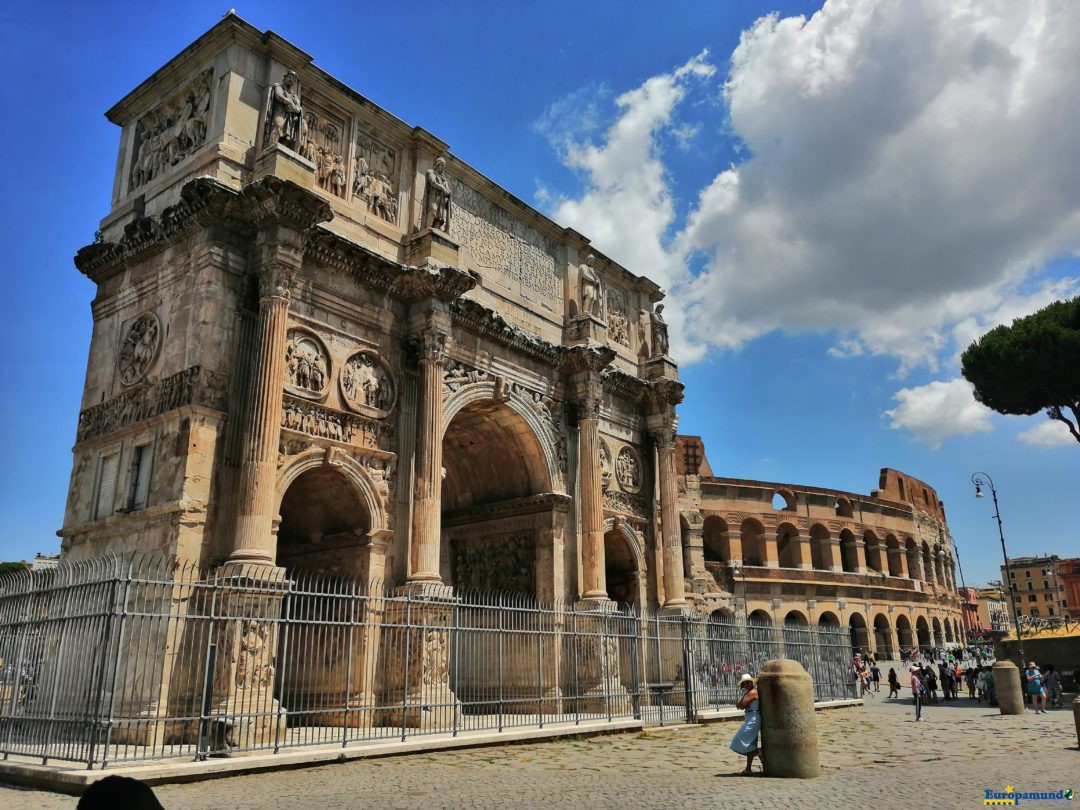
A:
[578, 396, 607, 599]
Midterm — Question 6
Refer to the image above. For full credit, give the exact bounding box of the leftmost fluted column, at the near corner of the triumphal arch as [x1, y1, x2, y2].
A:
[229, 266, 295, 565]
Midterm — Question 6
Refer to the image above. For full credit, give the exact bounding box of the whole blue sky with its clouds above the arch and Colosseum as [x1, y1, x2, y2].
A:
[0, 0, 1080, 584]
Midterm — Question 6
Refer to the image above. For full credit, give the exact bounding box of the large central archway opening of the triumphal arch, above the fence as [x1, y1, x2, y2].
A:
[441, 390, 569, 598]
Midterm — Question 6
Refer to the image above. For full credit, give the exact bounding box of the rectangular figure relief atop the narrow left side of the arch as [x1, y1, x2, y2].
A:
[131, 70, 214, 191]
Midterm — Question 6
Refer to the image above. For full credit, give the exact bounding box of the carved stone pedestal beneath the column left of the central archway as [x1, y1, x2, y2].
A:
[376, 584, 461, 729]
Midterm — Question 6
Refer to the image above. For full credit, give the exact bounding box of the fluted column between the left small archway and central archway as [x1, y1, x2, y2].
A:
[408, 330, 446, 583]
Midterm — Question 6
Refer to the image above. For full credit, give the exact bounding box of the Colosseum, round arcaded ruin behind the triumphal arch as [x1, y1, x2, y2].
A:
[677, 436, 963, 658]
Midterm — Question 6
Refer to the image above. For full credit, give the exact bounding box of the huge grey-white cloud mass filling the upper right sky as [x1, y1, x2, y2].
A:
[545, 0, 1080, 376]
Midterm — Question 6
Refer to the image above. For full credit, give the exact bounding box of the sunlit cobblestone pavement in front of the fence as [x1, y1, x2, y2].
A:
[0, 678, 1080, 810]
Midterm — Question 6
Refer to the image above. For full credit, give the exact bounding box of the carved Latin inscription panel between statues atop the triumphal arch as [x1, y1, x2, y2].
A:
[449, 177, 563, 309]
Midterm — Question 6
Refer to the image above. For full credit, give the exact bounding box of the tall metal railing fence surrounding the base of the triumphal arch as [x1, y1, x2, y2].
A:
[0, 557, 855, 768]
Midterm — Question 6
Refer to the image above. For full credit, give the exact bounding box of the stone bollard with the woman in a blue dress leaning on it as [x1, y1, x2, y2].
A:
[757, 659, 821, 779]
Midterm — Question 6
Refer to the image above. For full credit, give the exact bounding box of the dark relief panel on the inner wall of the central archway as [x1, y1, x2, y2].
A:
[450, 531, 536, 593]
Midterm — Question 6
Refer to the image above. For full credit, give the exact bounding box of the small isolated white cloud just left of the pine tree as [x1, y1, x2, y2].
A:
[885, 377, 993, 449]
